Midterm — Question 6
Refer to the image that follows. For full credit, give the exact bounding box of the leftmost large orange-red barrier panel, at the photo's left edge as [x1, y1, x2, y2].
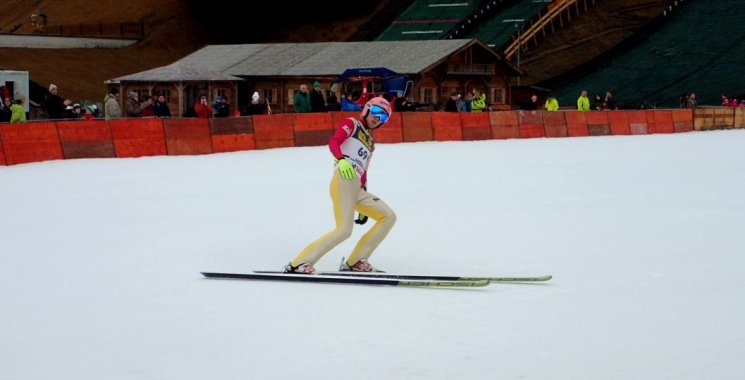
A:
[0, 122, 64, 165]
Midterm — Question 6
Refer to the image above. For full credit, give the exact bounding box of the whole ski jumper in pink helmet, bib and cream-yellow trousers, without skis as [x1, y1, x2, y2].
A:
[284, 97, 396, 274]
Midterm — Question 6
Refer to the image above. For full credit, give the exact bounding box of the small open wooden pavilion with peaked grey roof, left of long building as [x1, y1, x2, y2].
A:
[106, 61, 243, 117]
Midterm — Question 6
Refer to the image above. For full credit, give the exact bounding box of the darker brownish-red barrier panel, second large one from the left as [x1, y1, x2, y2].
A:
[57, 120, 116, 159]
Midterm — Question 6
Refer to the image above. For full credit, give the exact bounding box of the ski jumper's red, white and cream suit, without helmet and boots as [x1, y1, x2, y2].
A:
[290, 118, 396, 266]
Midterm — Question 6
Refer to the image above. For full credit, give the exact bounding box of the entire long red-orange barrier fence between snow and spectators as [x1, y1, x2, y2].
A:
[0, 108, 745, 165]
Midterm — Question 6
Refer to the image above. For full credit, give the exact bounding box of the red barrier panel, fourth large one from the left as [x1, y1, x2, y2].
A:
[163, 118, 211, 156]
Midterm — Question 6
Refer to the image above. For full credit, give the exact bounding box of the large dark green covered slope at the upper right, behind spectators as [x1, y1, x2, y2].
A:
[554, 0, 745, 108]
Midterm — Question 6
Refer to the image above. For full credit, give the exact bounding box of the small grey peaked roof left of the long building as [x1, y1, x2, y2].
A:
[106, 61, 244, 83]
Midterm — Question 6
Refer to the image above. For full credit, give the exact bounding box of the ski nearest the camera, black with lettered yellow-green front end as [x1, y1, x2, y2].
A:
[201, 272, 489, 288]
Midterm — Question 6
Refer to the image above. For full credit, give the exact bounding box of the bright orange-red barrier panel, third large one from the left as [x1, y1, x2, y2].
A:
[111, 118, 168, 157]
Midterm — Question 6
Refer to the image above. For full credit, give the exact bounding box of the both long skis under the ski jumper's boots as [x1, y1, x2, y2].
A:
[202, 271, 551, 288]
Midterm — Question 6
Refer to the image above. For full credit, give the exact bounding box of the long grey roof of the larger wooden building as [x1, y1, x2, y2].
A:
[178, 39, 519, 76]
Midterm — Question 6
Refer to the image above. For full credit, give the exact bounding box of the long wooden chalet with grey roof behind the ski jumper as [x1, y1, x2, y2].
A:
[177, 39, 521, 113]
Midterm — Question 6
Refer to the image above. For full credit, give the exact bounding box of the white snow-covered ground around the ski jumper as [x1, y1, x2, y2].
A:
[0, 130, 745, 380]
